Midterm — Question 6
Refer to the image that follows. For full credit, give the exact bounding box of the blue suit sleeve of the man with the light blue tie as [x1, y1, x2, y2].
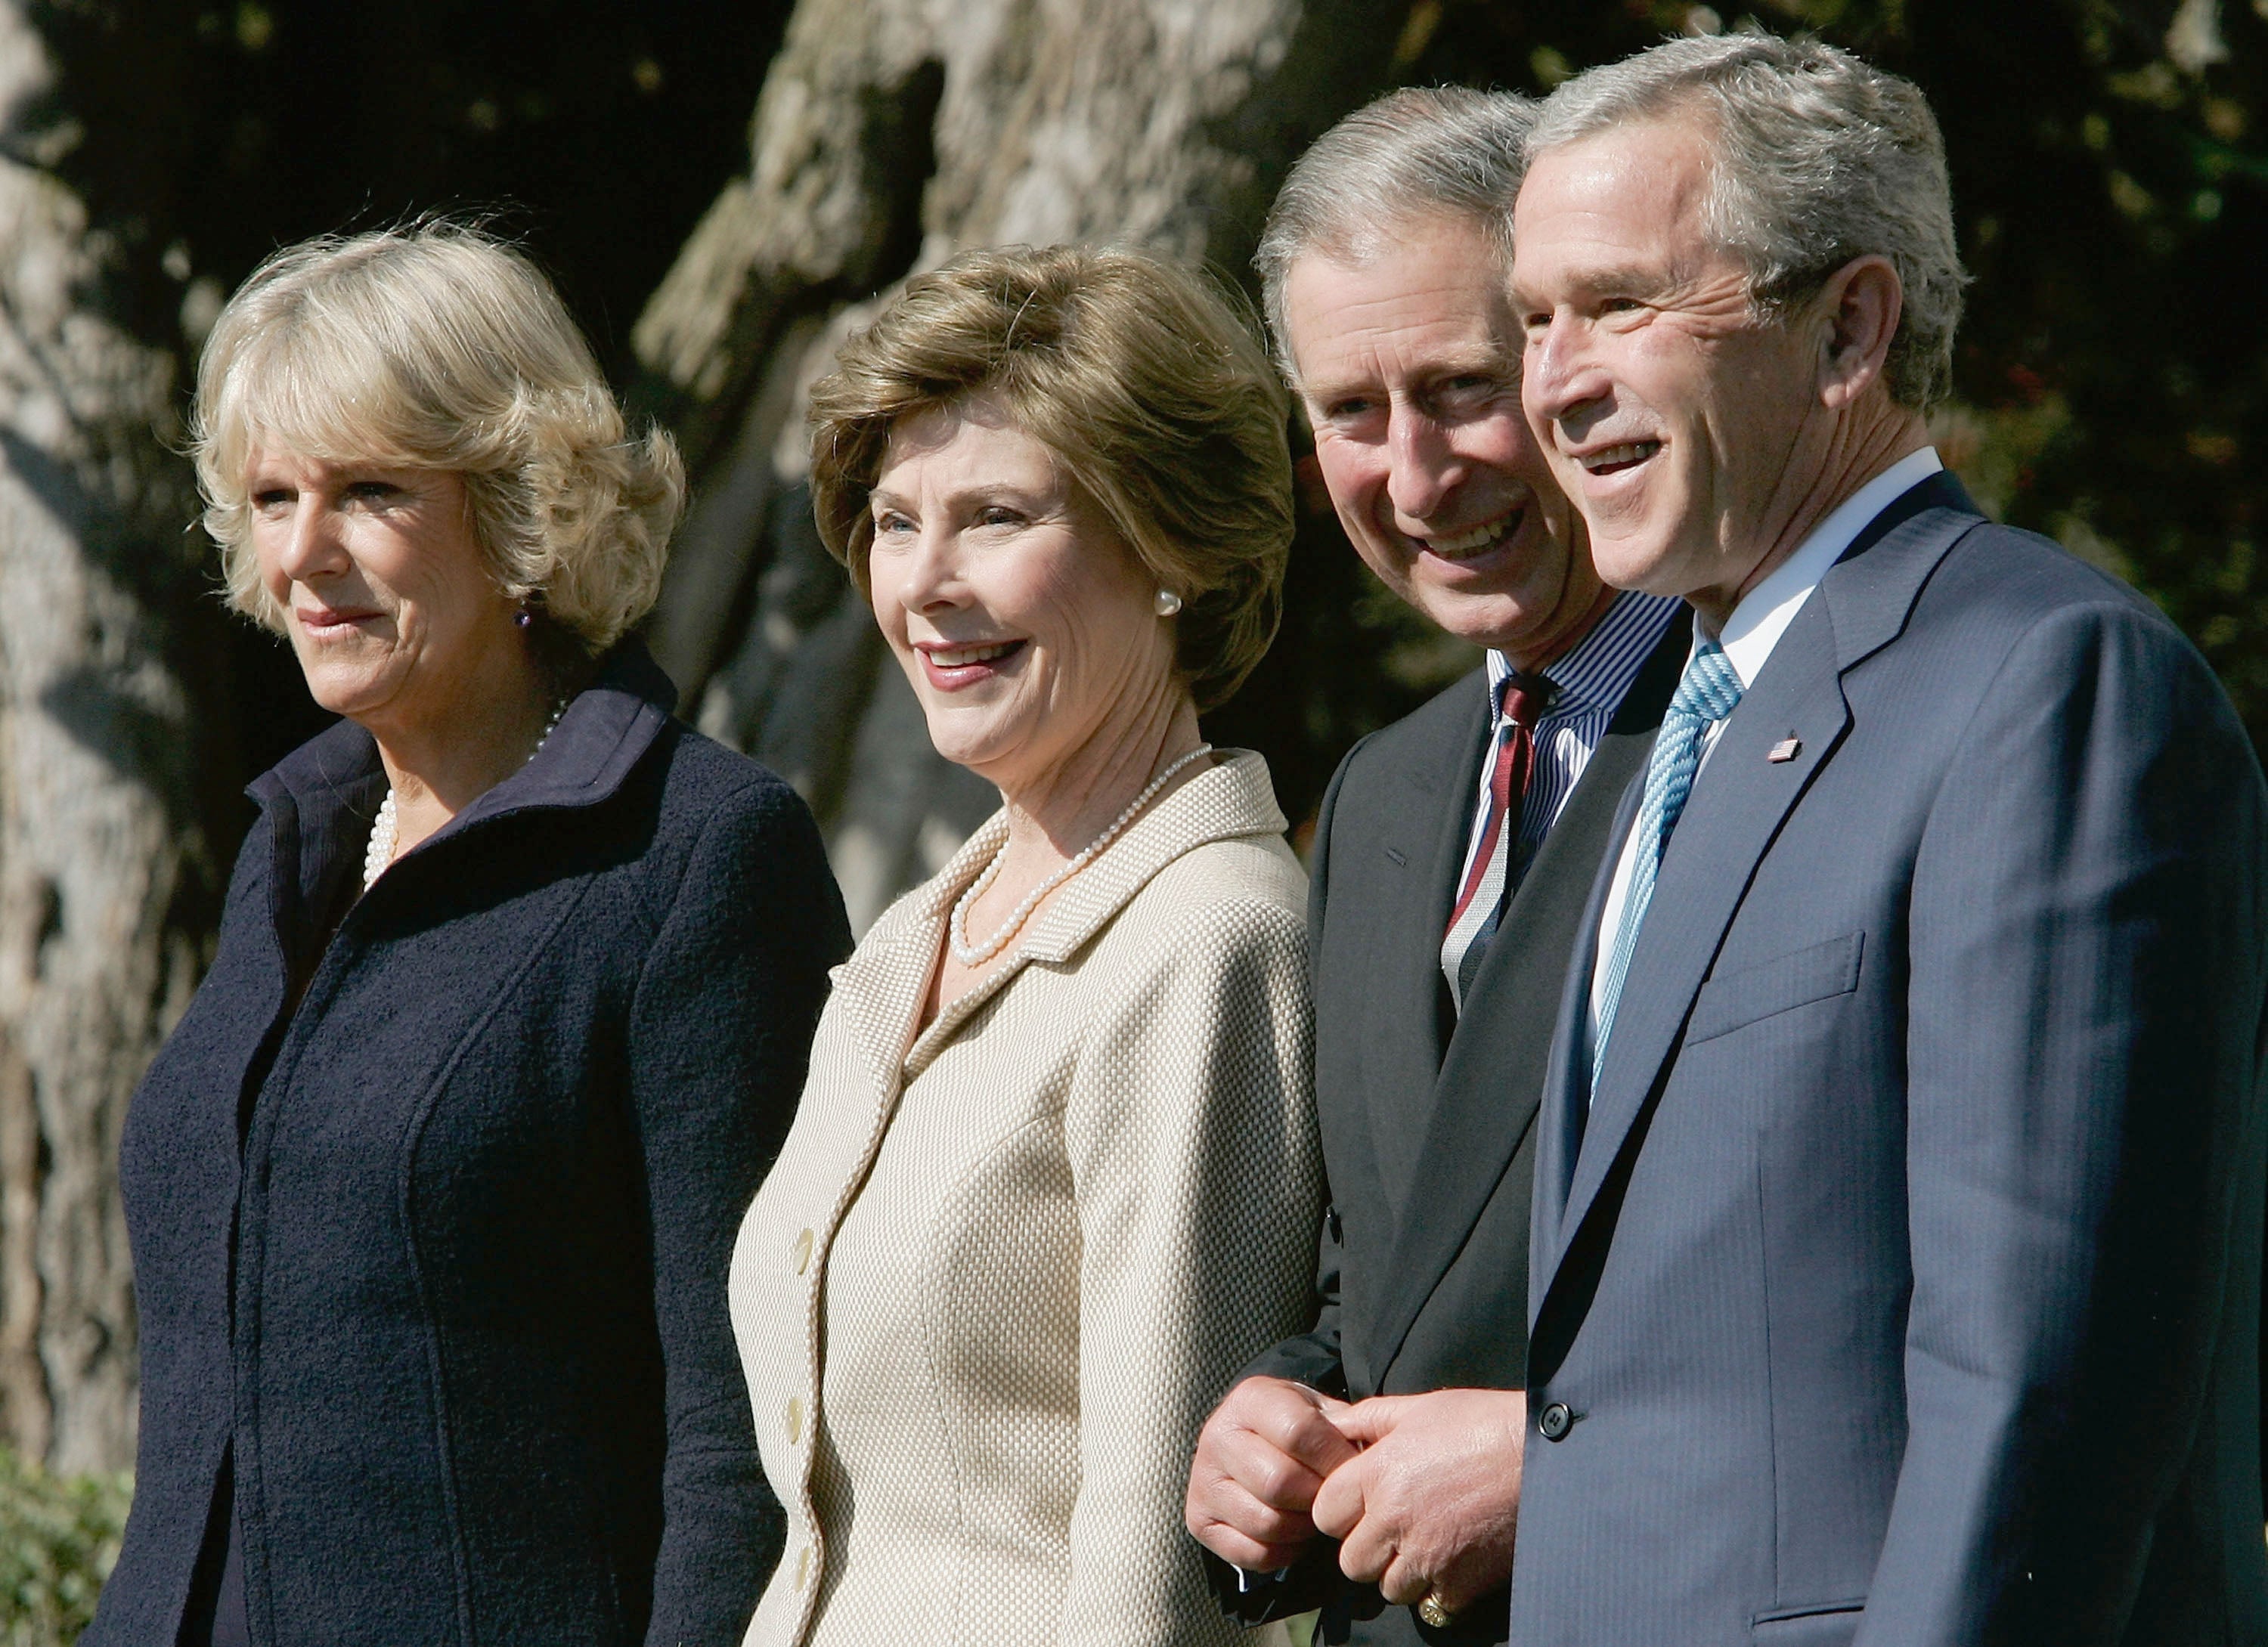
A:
[1857, 603, 2263, 1647]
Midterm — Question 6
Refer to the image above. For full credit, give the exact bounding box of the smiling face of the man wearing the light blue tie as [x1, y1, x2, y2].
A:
[1513, 118, 1833, 619]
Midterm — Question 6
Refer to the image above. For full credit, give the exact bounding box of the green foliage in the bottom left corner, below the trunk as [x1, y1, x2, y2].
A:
[0, 1447, 134, 1647]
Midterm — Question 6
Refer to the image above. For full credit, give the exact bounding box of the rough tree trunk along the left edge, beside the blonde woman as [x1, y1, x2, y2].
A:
[0, 0, 202, 1470]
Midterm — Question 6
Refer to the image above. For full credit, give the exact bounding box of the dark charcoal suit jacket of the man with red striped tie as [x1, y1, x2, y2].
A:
[1209, 621, 1692, 1647]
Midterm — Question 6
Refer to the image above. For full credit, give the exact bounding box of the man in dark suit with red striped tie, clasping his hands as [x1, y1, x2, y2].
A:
[1188, 91, 1685, 1647]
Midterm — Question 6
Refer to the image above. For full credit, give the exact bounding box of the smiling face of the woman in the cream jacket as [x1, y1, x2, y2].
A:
[866, 401, 1182, 798]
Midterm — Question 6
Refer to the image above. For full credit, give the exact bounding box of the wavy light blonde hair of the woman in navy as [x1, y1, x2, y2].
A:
[191, 220, 685, 651]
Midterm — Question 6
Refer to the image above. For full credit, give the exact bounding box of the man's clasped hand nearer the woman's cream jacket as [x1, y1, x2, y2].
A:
[1184, 1377, 1356, 1572]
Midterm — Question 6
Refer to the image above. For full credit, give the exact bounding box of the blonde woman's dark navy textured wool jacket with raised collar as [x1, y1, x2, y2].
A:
[84, 642, 850, 1647]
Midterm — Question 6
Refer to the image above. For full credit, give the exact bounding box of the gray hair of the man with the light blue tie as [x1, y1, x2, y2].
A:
[1529, 29, 1969, 410]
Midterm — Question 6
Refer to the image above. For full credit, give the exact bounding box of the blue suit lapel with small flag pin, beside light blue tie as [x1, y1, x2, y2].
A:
[1529, 476, 1980, 1320]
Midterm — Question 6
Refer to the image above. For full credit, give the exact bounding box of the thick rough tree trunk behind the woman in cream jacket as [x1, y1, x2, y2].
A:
[635, 0, 1422, 926]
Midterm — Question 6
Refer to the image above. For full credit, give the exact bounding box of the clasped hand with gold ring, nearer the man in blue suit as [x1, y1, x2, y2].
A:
[1306, 1391, 1529, 1613]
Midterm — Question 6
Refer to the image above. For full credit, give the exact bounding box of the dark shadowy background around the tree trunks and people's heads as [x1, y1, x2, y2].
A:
[43, 0, 2268, 862]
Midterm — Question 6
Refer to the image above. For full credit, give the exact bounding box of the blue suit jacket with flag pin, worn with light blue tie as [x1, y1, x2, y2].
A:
[1513, 476, 2268, 1647]
